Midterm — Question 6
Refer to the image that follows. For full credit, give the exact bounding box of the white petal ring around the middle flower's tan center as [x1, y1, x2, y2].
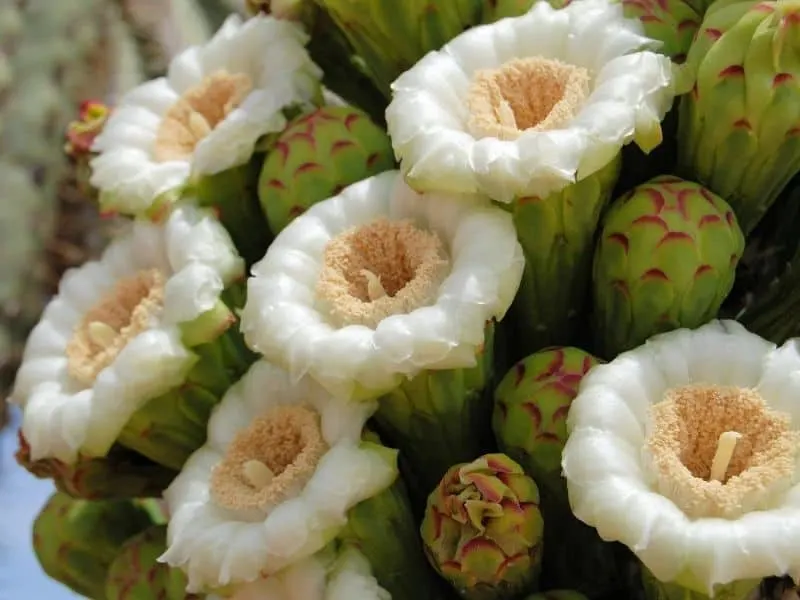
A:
[241, 171, 524, 398]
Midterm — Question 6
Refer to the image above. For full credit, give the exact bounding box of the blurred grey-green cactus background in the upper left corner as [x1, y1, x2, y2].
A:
[0, 0, 241, 426]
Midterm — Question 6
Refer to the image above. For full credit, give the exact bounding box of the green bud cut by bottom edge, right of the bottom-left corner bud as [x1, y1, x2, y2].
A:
[104, 524, 200, 600]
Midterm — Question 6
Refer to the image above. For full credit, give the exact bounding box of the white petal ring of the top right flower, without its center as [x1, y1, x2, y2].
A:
[386, 0, 674, 202]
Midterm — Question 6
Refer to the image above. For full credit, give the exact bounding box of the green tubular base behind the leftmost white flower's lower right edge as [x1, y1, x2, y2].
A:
[112, 327, 256, 470]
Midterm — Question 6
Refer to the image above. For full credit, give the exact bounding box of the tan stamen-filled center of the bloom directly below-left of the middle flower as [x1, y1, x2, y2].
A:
[211, 406, 328, 510]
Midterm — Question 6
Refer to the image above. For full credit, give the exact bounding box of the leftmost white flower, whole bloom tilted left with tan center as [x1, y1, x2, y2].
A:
[12, 207, 244, 462]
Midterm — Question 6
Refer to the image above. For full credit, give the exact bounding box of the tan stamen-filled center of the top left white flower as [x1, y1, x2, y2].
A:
[153, 71, 253, 162]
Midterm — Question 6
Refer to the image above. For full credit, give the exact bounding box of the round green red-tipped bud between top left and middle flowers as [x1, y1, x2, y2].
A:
[258, 106, 394, 234]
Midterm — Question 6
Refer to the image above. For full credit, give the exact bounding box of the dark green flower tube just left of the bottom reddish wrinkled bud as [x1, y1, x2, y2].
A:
[340, 468, 446, 600]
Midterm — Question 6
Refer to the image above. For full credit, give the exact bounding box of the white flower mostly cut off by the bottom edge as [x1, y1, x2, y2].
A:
[210, 547, 391, 600]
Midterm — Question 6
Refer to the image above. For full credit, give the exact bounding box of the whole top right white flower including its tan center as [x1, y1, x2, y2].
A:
[386, 0, 674, 202]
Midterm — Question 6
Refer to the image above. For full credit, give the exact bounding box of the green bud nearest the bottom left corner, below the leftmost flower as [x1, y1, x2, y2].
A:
[33, 493, 157, 600]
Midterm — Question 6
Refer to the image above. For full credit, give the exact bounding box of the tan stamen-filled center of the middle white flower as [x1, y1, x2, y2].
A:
[317, 219, 449, 328]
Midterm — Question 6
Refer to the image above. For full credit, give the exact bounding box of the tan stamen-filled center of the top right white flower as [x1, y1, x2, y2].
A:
[467, 56, 591, 140]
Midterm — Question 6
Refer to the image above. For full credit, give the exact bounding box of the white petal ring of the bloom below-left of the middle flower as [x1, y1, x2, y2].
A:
[163, 361, 397, 588]
